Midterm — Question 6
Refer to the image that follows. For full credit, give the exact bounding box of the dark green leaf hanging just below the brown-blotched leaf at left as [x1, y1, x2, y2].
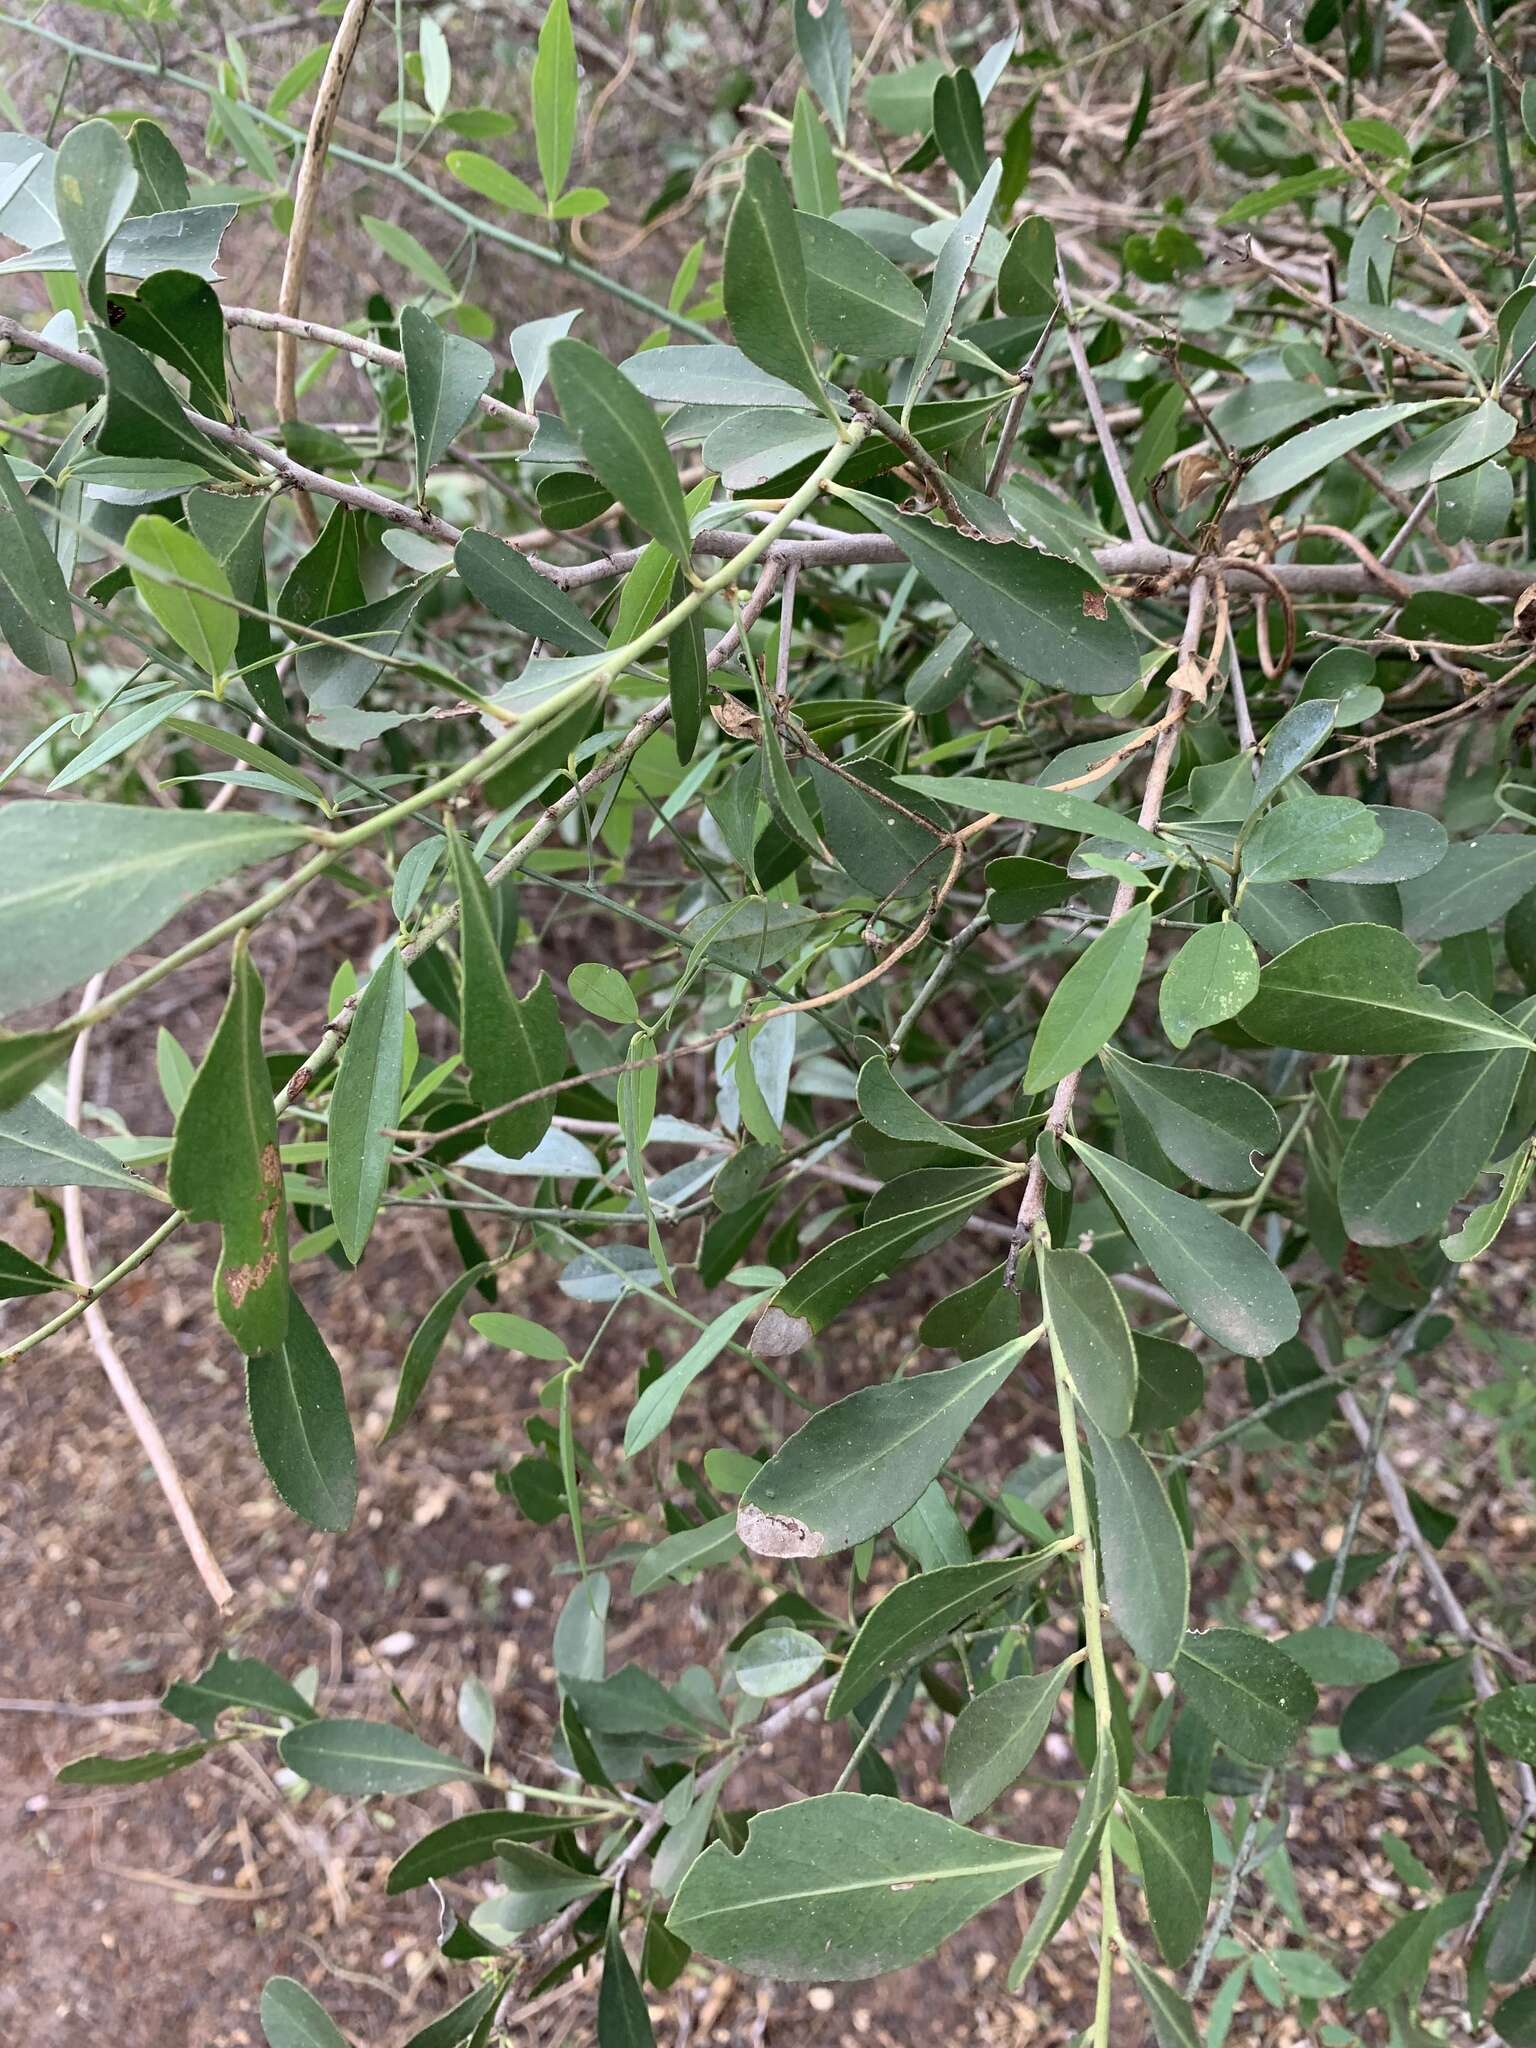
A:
[246, 1294, 356, 1530]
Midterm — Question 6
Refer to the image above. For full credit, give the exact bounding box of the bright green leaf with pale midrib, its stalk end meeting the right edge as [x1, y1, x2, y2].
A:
[1239, 929, 1532, 1053]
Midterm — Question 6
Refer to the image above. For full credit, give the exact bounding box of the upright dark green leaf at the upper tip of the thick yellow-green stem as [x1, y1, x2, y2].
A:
[725, 145, 836, 418]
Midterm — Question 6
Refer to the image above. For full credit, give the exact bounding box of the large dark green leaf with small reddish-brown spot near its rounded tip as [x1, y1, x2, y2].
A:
[838, 489, 1165, 700]
